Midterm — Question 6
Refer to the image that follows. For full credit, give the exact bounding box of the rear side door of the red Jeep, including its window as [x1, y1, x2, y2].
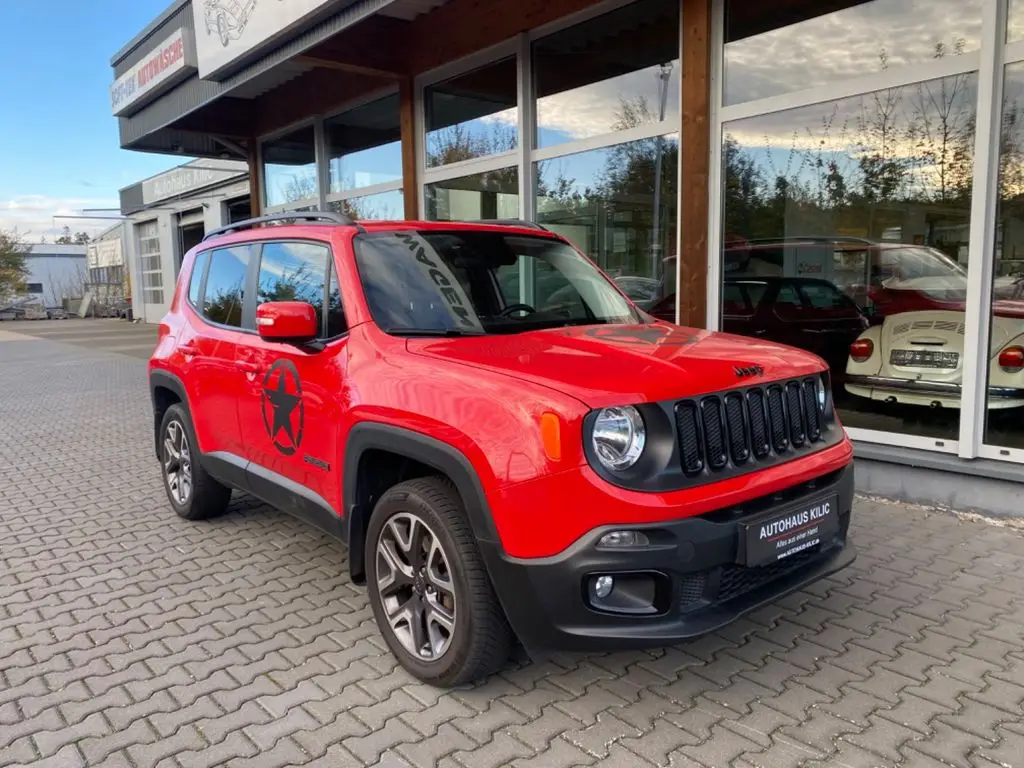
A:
[179, 245, 255, 467]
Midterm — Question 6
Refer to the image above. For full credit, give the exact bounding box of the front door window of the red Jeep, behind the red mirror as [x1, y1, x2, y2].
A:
[256, 243, 345, 338]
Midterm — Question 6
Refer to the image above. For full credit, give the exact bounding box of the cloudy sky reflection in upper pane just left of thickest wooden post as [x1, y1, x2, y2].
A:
[537, 61, 679, 146]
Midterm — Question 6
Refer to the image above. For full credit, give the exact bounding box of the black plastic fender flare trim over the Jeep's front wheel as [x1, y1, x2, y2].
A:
[342, 422, 499, 574]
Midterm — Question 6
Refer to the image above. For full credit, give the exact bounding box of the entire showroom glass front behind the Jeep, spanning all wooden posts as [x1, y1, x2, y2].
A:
[249, 0, 1024, 463]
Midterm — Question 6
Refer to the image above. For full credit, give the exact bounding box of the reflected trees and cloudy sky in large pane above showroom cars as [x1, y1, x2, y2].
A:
[723, 48, 977, 256]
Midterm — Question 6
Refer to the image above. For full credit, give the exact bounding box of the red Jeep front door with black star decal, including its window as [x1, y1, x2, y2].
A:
[236, 241, 348, 527]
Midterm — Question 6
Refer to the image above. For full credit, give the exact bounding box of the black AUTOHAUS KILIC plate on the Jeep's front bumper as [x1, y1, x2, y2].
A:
[737, 496, 839, 566]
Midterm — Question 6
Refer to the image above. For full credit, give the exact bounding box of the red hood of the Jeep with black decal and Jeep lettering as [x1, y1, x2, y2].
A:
[408, 323, 825, 408]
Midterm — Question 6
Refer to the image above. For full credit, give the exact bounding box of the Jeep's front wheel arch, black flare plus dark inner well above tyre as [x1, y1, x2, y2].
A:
[342, 422, 498, 584]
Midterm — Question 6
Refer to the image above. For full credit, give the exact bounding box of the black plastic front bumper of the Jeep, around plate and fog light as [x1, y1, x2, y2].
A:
[481, 462, 856, 657]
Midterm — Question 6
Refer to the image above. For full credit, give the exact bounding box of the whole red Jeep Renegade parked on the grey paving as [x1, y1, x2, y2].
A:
[150, 212, 855, 686]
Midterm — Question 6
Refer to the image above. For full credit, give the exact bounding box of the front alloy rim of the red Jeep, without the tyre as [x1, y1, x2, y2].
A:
[377, 512, 457, 662]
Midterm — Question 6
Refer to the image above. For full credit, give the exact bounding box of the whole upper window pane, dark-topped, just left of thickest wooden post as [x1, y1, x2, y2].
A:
[534, 0, 679, 146]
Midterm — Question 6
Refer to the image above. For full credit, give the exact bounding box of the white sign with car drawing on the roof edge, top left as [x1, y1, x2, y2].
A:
[191, 0, 336, 78]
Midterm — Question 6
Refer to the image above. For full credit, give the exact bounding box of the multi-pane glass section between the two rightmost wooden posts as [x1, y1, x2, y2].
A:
[419, 0, 680, 309]
